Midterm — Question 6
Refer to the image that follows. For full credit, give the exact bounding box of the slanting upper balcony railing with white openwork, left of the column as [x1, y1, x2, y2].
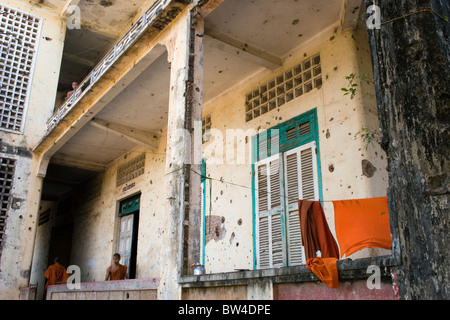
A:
[46, 0, 172, 135]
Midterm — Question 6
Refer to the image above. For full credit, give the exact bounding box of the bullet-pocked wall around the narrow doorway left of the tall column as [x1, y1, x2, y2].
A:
[71, 141, 169, 282]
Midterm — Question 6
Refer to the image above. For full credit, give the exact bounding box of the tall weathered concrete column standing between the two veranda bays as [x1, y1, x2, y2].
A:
[159, 5, 203, 299]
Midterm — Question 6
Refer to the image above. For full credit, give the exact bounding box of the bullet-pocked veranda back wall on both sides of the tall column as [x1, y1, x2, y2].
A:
[27, 5, 388, 296]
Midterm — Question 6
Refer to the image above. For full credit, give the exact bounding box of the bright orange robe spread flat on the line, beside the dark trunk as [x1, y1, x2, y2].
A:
[333, 197, 392, 257]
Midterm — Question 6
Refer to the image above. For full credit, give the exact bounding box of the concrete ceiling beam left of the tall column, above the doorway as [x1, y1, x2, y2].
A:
[90, 118, 159, 150]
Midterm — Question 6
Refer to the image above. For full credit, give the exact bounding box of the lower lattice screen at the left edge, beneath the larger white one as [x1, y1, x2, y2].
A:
[0, 158, 16, 254]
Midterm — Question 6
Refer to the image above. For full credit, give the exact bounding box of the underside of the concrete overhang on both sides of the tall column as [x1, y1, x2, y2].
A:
[34, 0, 348, 178]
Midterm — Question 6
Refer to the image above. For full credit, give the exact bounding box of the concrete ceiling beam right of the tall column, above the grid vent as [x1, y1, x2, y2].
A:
[205, 28, 282, 70]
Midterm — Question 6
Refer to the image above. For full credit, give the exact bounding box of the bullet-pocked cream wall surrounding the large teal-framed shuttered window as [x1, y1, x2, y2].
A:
[203, 26, 390, 273]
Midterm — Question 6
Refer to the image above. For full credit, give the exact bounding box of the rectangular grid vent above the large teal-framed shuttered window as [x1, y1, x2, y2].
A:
[245, 54, 322, 122]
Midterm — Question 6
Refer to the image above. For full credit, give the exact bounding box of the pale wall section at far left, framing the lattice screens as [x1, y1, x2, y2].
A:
[0, 0, 66, 300]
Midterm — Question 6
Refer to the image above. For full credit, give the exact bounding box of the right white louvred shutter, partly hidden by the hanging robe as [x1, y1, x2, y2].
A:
[284, 142, 318, 266]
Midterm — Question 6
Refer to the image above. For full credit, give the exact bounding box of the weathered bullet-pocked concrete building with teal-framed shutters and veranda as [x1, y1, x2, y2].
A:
[0, 0, 428, 299]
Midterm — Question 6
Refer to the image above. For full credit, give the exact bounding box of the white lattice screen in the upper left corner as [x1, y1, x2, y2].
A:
[0, 4, 41, 132]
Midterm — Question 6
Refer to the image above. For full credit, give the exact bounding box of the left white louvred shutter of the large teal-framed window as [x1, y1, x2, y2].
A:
[256, 155, 285, 269]
